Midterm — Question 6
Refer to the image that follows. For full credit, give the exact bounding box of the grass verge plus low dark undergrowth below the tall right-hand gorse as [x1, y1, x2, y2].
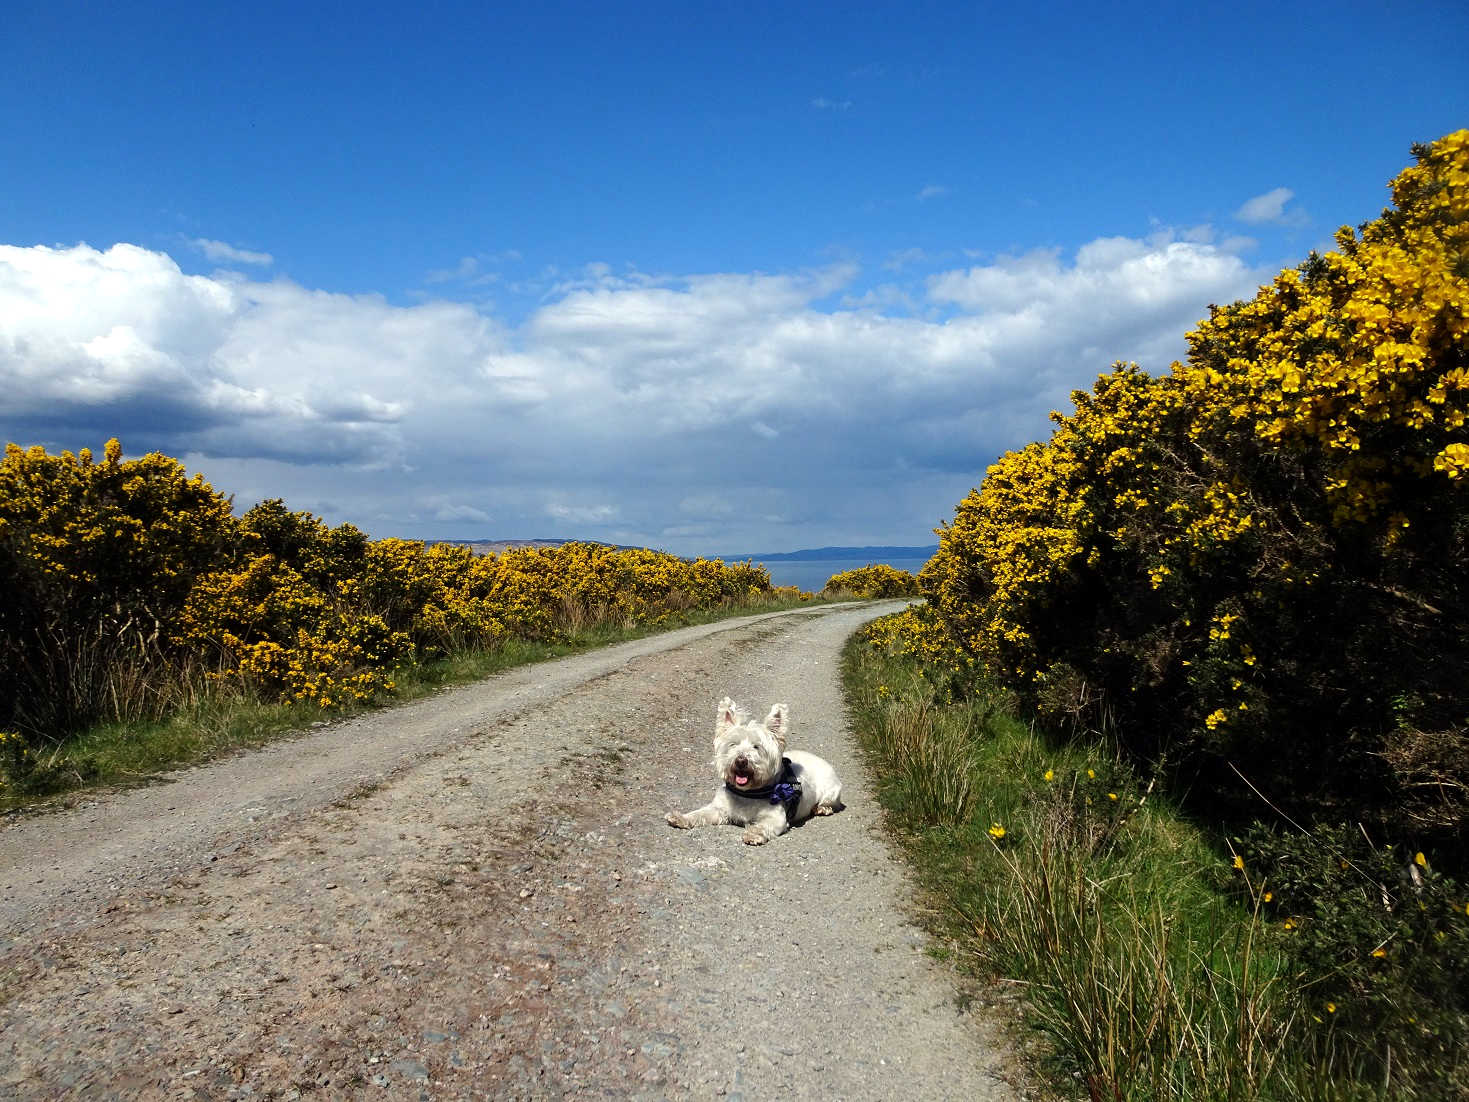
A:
[845, 610, 1469, 1102]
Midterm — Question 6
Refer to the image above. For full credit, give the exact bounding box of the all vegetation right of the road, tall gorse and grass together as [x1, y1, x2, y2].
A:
[849, 131, 1469, 1099]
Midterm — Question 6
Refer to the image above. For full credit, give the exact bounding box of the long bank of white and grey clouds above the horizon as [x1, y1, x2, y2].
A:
[0, 234, 1262, 554]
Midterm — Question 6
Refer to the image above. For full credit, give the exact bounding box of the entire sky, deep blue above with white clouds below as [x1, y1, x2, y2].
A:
[0, 0, 1469, 554]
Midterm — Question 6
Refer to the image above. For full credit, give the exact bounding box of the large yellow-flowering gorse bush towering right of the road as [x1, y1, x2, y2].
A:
[920, 131, 1469, 839]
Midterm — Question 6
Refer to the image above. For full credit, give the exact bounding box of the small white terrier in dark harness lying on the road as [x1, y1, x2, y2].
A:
[668, 696, 842, 846]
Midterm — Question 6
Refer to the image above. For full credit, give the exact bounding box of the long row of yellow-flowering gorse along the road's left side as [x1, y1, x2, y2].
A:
[0, 441, 773, 752]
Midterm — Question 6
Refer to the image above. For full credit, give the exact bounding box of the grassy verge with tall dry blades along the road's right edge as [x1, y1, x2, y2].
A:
[843, 617, 1466, 1102]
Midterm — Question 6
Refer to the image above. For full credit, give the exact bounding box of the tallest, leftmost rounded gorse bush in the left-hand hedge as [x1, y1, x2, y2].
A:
[0, 441, 235, 743]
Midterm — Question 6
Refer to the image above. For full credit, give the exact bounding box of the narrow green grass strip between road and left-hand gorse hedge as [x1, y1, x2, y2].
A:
[0, 599, 826, 811]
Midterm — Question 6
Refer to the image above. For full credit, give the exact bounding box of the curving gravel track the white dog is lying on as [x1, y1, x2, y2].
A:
[0, 605, 1018, 1101]
